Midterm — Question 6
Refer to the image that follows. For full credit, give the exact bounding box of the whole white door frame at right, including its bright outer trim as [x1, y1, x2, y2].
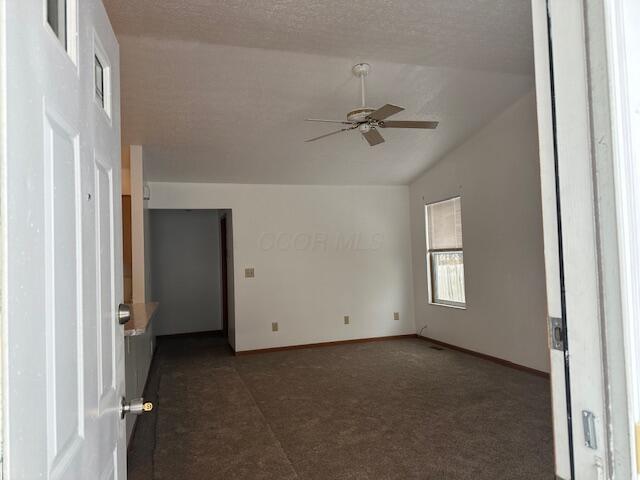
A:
[532, 0, 640, 480]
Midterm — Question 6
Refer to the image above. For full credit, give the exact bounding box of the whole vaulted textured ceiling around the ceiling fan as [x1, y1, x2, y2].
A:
[105, 0, 533, 185]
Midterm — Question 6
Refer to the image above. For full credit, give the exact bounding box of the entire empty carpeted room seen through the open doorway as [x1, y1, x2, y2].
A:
[106, 1, 554, 479]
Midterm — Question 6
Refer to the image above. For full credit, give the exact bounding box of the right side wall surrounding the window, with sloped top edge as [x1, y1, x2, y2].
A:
[410, 92, 549, 372]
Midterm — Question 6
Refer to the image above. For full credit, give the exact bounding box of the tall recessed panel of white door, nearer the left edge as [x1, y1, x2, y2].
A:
[44, 107, 84, 478]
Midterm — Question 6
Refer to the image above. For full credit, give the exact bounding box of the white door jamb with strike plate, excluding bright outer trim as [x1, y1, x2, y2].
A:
[532, 0, 632, 479]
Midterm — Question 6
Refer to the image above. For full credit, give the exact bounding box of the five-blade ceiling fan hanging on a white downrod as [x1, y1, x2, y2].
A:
[305, 63, 438, 147]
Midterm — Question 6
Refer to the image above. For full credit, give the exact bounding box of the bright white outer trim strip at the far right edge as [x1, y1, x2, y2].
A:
[604, 0, 640, 478]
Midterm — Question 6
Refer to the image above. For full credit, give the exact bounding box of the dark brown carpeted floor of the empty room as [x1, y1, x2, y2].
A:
[129, 337, 554, 480]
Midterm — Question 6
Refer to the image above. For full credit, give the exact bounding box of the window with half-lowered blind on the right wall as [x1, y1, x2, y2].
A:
[425, 197, 466, 307]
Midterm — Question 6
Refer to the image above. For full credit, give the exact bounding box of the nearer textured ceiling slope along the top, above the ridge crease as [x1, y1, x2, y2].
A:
[105, 0, 533, 73]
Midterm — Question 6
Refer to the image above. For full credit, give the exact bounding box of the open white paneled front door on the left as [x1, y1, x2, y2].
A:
[1, 0, 126, 480]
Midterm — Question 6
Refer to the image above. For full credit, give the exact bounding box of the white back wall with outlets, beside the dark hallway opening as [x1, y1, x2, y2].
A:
[150, 183, 415, 351]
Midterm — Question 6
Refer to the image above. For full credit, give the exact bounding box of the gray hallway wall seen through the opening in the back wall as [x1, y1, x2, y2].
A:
[150, 210, 222, 335]
